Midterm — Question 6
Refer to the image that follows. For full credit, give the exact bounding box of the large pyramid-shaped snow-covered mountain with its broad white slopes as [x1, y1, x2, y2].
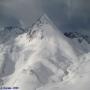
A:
[0, 15, 90, 90]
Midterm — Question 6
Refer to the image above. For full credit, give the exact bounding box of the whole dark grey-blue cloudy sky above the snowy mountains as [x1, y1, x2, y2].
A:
[0, 0, 90, 30]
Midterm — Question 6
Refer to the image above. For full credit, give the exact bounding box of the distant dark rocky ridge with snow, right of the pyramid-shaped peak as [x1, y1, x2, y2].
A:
[64, 32, 90, 52]
